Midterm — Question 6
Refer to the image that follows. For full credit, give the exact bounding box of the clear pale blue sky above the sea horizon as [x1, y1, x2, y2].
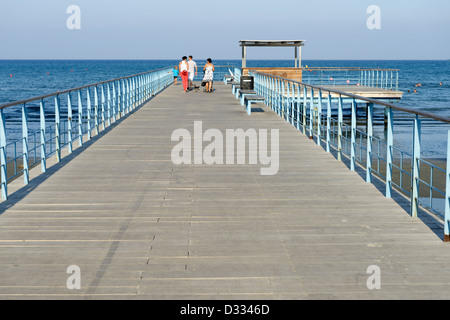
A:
[0, 0, 450, 60]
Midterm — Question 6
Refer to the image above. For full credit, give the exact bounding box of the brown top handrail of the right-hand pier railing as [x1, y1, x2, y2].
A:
[249, 68, 450, 123]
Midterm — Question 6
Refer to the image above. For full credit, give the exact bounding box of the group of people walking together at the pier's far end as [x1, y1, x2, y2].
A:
[173, 56, 215, 93]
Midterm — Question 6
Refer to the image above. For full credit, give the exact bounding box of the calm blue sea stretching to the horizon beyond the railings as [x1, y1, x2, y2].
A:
[0, 60, 450, 158]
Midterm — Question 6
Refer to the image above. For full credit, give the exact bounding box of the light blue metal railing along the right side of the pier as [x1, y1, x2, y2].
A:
[243, 70, 450, 241]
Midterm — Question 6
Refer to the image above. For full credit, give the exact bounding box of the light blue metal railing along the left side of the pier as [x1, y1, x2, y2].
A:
[0, 67, 173, 200]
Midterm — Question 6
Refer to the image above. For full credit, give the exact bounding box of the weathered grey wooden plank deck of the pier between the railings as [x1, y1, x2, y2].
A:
[0, 82, 450, 300]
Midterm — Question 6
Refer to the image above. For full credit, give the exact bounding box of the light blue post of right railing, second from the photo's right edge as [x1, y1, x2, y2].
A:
[411, 115, 422, 218]
